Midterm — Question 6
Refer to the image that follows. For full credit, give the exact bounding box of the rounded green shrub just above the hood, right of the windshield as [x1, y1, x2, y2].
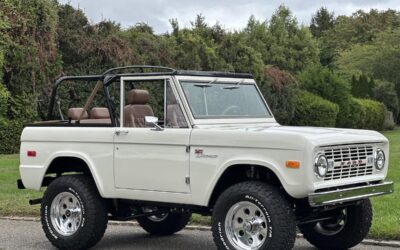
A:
[291, 91, 339, 127]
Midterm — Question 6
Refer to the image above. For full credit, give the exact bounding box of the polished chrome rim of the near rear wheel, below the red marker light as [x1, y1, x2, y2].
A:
[50, 192, 82, 236]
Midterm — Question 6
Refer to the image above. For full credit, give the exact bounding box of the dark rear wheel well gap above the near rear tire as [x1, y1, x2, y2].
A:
[46, 156, 93, 178]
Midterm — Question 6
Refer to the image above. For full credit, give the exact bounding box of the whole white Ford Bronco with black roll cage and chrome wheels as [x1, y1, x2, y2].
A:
[18, 66, 393, 250]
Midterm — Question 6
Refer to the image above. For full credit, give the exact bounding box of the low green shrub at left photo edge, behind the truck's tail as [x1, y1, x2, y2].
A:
[0, 119, 23, 154]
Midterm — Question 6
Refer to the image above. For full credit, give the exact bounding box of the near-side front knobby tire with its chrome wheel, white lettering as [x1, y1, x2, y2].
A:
[212, 181, 296, 250]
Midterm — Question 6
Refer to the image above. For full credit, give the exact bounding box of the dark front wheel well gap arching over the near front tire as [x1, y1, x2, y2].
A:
[208, 164, 282, 207]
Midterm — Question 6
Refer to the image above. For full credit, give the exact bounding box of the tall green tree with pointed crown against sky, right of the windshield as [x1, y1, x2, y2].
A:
[244, 6, 318, 72]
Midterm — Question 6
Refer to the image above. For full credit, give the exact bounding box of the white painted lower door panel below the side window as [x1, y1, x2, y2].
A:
[114, 128, 190, 193]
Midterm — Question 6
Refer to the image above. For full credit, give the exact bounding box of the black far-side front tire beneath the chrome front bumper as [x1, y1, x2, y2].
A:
[299, 199, 372, 249]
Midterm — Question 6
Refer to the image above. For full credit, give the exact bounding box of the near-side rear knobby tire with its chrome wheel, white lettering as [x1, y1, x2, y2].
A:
[41, 175, 108, 249]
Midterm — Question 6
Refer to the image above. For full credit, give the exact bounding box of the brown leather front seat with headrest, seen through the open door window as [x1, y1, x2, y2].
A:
[123, 89, 154, 127]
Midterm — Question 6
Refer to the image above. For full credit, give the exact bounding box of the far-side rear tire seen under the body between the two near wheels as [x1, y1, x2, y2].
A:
[136, 212, 192, 236]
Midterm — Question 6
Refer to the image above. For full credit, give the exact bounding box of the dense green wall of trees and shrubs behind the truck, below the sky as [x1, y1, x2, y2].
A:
[0, 0, 400, 153]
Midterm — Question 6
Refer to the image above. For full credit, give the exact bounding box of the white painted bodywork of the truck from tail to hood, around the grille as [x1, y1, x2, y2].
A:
[20, 123, 388, 205]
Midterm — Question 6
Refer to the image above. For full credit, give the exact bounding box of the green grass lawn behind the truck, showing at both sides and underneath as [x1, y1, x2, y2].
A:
[0, 129, 400, 240]
